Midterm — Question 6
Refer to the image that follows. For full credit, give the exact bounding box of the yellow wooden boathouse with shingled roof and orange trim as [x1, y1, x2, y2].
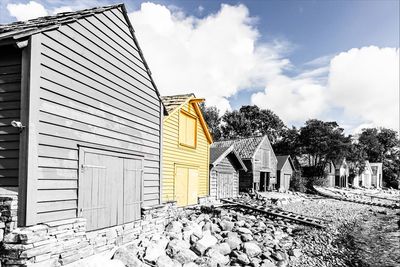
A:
[162, 94, 212, 206]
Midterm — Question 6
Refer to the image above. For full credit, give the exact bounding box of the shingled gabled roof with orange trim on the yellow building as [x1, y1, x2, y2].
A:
[161, 93, 213, 144]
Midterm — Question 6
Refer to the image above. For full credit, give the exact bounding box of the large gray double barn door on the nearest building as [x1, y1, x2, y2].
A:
[78, 149, 143, 230]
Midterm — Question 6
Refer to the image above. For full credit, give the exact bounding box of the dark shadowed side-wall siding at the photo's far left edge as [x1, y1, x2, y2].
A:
[0, 46, 21, 186]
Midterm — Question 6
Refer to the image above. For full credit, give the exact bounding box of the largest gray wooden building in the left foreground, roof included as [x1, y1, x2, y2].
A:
[0, 5, 163, 230]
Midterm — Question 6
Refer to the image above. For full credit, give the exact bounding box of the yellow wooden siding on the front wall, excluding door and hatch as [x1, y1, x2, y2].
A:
[162, 103, 210, 201]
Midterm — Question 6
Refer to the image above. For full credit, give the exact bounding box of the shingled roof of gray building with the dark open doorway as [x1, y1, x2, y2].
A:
[212, 136, 267, 159]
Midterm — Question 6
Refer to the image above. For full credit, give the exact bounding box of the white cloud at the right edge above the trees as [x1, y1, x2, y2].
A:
[328, 46, 400, 133]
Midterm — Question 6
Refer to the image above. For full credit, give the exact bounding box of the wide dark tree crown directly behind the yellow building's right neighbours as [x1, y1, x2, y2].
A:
[221, 105, 285, 143]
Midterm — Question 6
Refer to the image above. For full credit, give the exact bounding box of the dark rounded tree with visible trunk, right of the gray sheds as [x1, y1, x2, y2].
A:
[299, 119, 351, 178]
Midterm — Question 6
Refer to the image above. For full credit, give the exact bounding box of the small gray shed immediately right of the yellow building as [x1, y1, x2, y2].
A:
[210, 142, 247, 199]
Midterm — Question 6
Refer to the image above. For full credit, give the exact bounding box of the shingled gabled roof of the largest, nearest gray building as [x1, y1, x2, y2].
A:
[0, 4, 165, 105]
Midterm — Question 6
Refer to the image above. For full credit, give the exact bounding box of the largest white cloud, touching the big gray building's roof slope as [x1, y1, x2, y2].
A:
[129, 3, 289, 111]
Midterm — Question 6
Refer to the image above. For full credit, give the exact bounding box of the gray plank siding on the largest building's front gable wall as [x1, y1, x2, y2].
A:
[37, 10, 161, 222]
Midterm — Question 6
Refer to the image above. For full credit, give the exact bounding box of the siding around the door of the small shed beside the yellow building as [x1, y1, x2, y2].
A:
[210, 158, 239, 199]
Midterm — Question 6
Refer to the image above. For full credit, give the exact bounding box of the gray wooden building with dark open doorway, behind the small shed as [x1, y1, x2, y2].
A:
[214, 136, 277, 192]
